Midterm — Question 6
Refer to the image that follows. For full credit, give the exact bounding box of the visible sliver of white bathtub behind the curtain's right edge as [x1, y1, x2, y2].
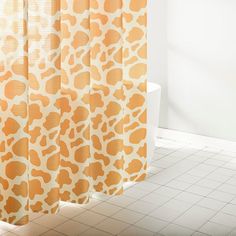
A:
[147, 82, 161, 163]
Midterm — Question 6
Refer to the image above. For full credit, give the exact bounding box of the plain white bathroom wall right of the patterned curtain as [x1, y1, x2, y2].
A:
[148, 0, 236, 141]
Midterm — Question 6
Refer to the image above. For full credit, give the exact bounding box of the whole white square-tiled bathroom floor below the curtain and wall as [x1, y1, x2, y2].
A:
[0, 139, 236, 236]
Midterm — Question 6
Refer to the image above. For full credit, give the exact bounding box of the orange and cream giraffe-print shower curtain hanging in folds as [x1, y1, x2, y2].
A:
[0, 0, 147, 225]
